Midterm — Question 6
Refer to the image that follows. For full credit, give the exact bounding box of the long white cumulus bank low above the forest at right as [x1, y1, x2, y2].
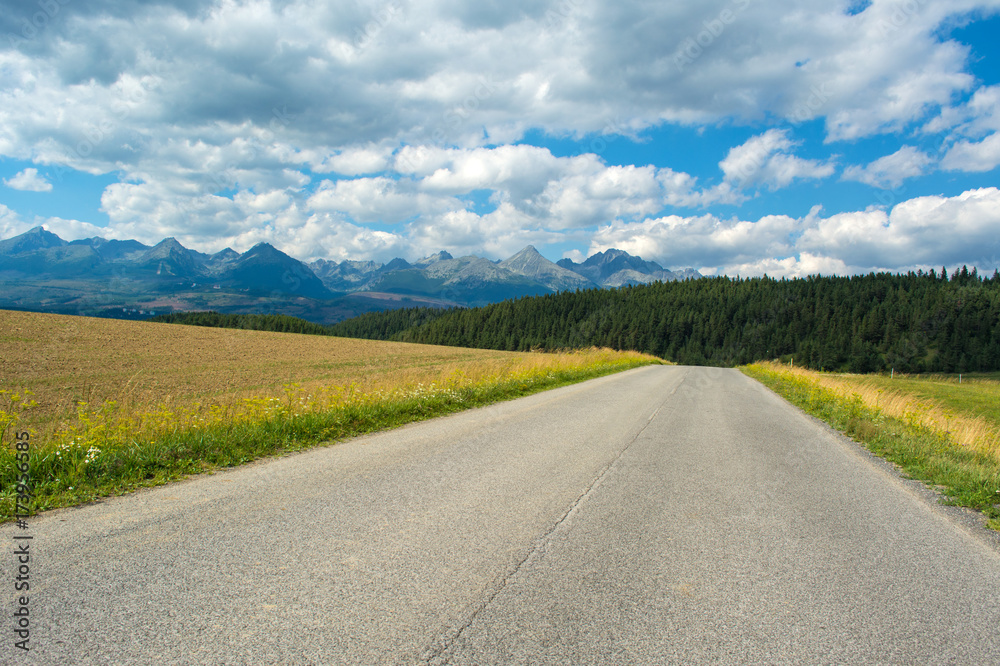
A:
[590, 188, 1000, 277]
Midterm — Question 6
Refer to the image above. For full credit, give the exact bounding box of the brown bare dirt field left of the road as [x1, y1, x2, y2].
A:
[0, 310, 549, 425]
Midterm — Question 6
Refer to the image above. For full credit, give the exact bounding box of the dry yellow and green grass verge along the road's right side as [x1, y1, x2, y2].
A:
[740, 363, 1000, 530]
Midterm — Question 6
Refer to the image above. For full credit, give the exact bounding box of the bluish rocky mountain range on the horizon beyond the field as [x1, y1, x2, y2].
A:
[0, 227, 700, 324]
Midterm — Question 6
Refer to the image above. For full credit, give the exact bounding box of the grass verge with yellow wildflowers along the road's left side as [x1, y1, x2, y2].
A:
[0, 350, 659, 522]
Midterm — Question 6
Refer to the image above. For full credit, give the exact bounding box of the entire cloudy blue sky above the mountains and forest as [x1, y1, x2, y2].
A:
[0, 0, 1000, 277]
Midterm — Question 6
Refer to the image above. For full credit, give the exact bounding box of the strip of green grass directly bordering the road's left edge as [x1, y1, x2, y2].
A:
[0, 358, 653, 522]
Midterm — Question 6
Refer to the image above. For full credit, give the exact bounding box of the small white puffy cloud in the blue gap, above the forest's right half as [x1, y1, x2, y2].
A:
[719, 129, 835, 190]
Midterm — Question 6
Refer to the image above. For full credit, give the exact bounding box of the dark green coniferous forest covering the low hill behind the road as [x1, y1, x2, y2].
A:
[329, 267, 1000, 372]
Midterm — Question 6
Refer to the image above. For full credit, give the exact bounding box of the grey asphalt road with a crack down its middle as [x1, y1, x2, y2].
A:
[0, 367, 1000, 665]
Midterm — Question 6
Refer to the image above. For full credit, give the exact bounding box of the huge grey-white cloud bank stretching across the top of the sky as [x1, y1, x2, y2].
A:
[0, 0, 998, 184]
